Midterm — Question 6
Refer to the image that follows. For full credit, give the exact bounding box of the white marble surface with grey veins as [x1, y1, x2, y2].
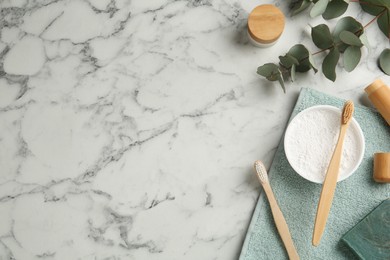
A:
[0, 0, 390, 260]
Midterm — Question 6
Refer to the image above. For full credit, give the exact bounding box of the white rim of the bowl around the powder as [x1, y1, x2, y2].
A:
[283, 105, 366, 184]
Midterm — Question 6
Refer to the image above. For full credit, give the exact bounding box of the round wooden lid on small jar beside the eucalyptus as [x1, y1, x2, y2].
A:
[248, 4, 284, 44]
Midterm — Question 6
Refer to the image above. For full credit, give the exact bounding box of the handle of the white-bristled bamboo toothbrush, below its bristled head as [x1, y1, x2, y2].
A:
[263, 183, 299, 260]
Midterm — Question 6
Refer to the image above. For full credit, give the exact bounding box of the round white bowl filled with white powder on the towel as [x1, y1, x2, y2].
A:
[284, 105, 365, 183]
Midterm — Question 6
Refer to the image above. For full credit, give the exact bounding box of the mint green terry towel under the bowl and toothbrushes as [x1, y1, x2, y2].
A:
[240, 88, 390, 260]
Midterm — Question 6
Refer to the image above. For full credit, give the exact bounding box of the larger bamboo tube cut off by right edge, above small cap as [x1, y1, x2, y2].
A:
[364, 79, 390, 125]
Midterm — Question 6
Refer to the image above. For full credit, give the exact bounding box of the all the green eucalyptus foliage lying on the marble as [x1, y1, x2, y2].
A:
[257, 0, 390, 91]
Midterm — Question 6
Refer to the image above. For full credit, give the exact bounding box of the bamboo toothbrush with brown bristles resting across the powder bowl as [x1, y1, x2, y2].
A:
[312, 101, 354, 246]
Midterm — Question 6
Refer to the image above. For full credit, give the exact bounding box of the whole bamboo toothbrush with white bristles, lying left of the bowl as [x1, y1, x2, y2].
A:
[255, 161, 299, 260]
